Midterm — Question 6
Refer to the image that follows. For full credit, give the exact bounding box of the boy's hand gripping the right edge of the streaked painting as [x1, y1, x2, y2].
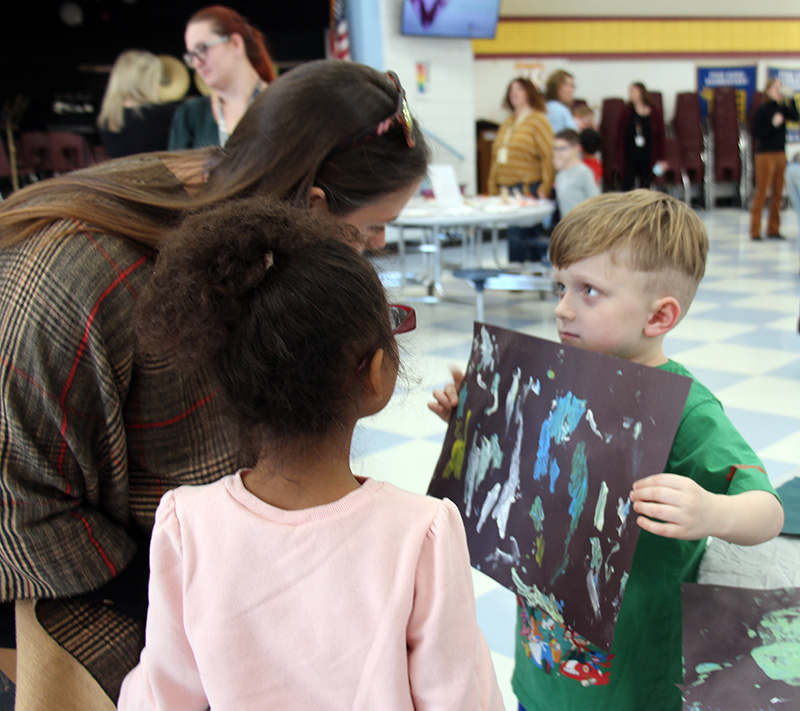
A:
[630, 474, 718, 541]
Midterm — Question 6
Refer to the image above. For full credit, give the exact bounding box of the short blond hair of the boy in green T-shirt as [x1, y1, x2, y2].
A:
[550, 190, 708, 313]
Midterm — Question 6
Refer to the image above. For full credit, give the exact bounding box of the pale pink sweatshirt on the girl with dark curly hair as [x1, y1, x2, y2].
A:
[119, 472, 504, 711]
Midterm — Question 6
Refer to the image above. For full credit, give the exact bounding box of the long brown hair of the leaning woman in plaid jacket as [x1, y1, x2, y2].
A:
[0, 60, 429, 247]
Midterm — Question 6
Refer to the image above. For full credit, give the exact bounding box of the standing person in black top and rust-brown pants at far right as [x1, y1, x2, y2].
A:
[750, 77, 800, 240]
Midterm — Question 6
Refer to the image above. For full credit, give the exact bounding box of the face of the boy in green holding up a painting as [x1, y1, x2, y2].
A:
[553, 254, 666, 365]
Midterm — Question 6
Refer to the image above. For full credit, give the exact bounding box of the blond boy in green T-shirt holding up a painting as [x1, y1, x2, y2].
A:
[430, 190, 783, 711]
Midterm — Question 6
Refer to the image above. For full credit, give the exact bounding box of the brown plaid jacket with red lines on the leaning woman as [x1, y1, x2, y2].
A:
[0, 210, 239, 699]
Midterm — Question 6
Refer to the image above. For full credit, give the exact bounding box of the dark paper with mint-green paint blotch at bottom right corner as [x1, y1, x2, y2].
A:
[681, 583, 800, 711]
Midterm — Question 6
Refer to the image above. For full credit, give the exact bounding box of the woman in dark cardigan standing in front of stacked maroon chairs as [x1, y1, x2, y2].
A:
[617, 82, 667, 191]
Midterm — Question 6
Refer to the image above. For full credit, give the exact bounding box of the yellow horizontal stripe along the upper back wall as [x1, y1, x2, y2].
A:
[472, 18, 800, 57]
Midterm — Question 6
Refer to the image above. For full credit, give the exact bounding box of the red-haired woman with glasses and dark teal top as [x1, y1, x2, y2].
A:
[169, 5, 276, 150]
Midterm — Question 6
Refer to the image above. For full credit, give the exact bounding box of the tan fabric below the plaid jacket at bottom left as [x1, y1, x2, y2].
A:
[14, 600, 117, 711]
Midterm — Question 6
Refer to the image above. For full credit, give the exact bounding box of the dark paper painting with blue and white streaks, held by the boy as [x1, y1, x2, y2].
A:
[428, 323, 690, 652]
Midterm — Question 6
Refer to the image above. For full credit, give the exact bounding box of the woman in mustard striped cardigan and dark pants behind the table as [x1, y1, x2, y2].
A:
[488, 77, 553, 262]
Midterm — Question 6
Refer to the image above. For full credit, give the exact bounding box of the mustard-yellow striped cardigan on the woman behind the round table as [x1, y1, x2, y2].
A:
[488, 111, 554, 196]
